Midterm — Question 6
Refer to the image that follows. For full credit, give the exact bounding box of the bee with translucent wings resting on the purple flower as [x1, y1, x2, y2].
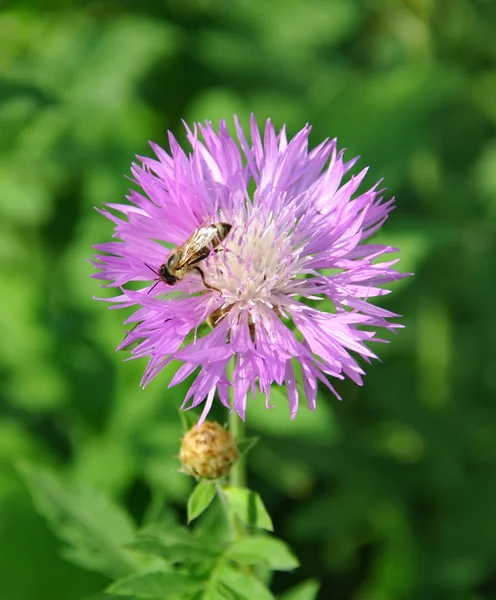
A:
[147, 222, 232, 292]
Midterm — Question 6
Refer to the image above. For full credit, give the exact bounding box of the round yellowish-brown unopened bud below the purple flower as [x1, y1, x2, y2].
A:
[179, 421, 238, 479]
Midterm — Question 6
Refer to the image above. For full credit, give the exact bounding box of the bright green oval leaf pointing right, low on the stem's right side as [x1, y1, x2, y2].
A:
[227, 535, 299, 571]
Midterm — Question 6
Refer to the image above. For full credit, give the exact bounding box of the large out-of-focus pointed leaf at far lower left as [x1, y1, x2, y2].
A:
[19, 464, 135, 577]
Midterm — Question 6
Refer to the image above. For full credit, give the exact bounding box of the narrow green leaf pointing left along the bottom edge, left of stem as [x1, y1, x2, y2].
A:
[107, 571, 205, 598]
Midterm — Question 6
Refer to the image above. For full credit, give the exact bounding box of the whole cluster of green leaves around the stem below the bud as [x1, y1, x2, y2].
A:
[20, 464, 298, 600]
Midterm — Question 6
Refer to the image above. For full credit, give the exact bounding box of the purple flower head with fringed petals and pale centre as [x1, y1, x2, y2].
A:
[94, 117, 405, 420]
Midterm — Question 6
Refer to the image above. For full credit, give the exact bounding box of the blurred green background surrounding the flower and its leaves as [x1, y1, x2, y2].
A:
[0, 0, 496, 600]
